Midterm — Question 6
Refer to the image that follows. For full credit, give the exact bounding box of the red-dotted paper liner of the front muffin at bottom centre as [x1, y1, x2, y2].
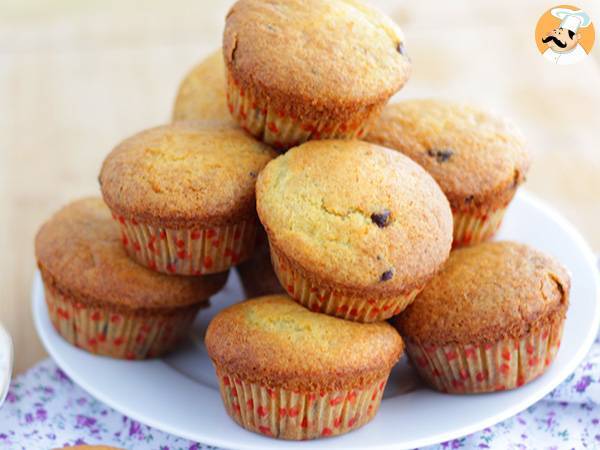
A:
[217, 369, 388, 440]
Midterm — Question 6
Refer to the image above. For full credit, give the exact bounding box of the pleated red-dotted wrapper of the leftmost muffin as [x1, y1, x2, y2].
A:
[45, 286, 201, 359]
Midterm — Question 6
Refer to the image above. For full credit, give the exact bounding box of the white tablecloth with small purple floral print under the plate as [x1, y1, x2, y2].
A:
[0, 338, 600, 450]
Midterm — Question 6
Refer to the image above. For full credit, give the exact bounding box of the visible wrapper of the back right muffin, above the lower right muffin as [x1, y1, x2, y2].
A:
[452, 208, 506, 248]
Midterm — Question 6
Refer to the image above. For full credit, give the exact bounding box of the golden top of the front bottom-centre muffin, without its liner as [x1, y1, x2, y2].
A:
[205, 295, 403, 391]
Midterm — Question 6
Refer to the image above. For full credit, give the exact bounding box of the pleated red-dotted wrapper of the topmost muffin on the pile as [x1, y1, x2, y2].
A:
[227, 74, 372, 149]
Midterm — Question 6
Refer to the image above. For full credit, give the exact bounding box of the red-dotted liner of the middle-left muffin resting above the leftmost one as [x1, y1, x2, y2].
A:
[113, 215, 258, 275]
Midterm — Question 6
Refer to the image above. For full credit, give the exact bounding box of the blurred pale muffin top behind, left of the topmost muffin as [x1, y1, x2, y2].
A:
[173, 49, 233, 122]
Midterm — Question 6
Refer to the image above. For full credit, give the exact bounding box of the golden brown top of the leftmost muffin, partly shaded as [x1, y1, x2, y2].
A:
[35, 197, 227, 309]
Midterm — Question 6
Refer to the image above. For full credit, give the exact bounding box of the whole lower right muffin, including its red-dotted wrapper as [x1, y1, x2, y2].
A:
[395, 242, 570, 394]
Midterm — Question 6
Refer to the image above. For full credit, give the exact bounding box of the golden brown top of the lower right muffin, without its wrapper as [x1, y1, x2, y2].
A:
[396, 241, 571, 345]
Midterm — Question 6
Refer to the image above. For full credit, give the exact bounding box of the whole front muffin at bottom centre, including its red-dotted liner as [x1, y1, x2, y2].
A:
[205, 295, 402, 440]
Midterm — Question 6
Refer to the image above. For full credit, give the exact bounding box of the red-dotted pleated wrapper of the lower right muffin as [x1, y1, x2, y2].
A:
[406, 321, 563, 394]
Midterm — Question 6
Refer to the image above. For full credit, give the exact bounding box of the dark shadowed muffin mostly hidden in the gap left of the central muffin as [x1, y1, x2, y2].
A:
[236, 229, 285, 298]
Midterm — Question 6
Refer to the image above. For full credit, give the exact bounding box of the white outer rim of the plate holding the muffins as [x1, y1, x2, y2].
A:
[31, 189, 600, 450]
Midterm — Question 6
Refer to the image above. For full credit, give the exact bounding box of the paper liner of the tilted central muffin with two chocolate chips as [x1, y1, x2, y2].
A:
[271, 246, 422, 322]
